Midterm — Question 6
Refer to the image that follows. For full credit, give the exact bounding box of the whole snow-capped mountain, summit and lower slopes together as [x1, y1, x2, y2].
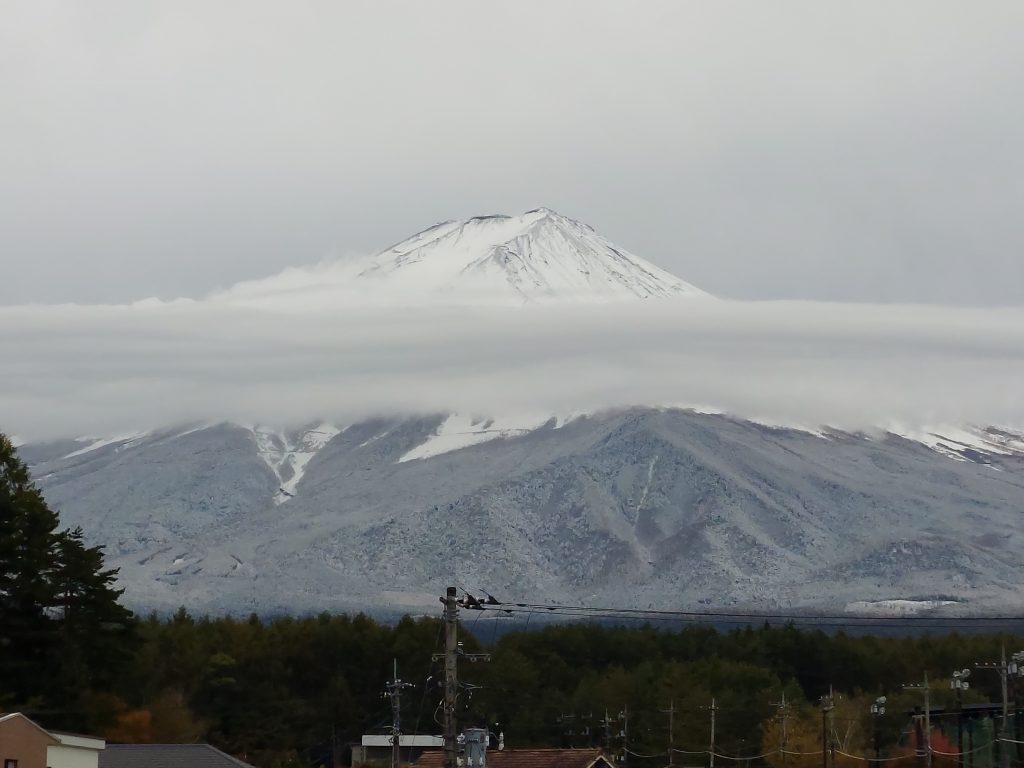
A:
[9, 209, 1024, 614]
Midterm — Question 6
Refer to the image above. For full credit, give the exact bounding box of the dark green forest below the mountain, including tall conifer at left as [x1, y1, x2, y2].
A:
[0, 435, 1024, 768]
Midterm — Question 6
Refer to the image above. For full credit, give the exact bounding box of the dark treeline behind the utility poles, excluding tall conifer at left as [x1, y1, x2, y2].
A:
[48, 610, 1024, 766]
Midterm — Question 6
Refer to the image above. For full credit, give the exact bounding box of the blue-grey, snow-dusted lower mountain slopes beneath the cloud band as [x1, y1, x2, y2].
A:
[23, 409, 1024, 612]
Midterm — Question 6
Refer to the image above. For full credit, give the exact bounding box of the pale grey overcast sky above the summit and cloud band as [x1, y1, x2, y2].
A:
[0, 0, 1024, 304]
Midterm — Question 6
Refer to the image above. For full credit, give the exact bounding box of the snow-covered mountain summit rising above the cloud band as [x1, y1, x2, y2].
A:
[215, 208, 709, 307]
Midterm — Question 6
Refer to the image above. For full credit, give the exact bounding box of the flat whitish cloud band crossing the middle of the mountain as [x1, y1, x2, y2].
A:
[0, 301, 1024, 440]
